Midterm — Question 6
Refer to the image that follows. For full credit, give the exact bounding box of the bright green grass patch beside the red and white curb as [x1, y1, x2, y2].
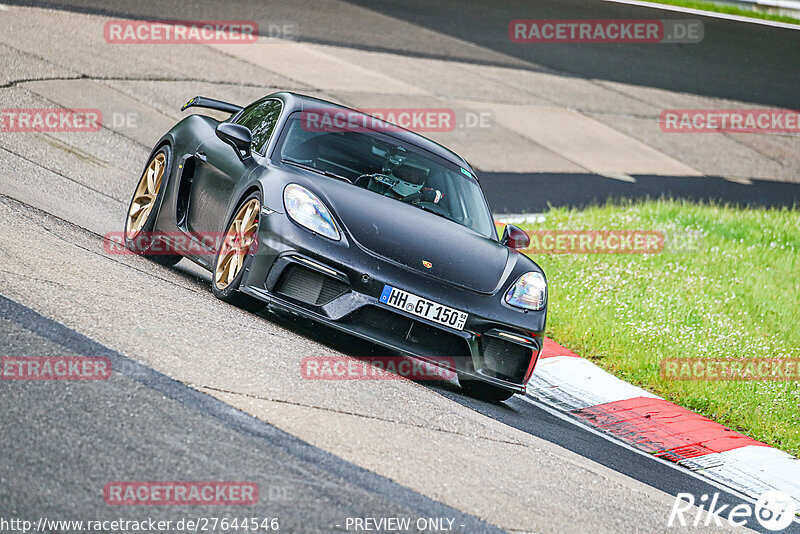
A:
[506, 201, 800, 455]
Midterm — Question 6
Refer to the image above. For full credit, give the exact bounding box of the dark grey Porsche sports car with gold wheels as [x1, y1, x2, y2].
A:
[125, 92, 547, 401]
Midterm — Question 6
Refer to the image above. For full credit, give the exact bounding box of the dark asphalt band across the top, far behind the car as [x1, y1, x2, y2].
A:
[7, 0, 800, 108]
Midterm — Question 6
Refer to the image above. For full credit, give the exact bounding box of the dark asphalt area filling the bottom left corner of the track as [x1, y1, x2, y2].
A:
[0, 296, 500, 532]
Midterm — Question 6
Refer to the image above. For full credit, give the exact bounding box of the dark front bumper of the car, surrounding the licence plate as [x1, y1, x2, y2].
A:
[240, 212, 545, 393]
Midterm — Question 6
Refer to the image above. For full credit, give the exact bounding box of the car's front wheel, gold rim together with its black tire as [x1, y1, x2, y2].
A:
[211, 191, 264, 311]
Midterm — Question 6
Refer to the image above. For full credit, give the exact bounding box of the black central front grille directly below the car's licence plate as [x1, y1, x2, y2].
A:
[350, 306, 470, 357]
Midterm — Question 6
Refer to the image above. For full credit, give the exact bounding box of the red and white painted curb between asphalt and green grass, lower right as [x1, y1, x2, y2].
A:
[528, 338, 800, 510]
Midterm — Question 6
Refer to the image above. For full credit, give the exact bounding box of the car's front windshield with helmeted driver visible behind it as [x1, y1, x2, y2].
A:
[276, 113, 495, 237]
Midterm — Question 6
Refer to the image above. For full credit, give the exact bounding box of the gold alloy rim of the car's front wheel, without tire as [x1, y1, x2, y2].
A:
[214, 198, 261, 289]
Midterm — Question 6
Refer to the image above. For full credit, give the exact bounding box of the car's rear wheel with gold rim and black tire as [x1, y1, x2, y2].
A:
[124, 145, 181, 267]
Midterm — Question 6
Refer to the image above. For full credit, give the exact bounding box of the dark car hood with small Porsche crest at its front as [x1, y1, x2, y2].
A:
[325, 184, 513, 293]
